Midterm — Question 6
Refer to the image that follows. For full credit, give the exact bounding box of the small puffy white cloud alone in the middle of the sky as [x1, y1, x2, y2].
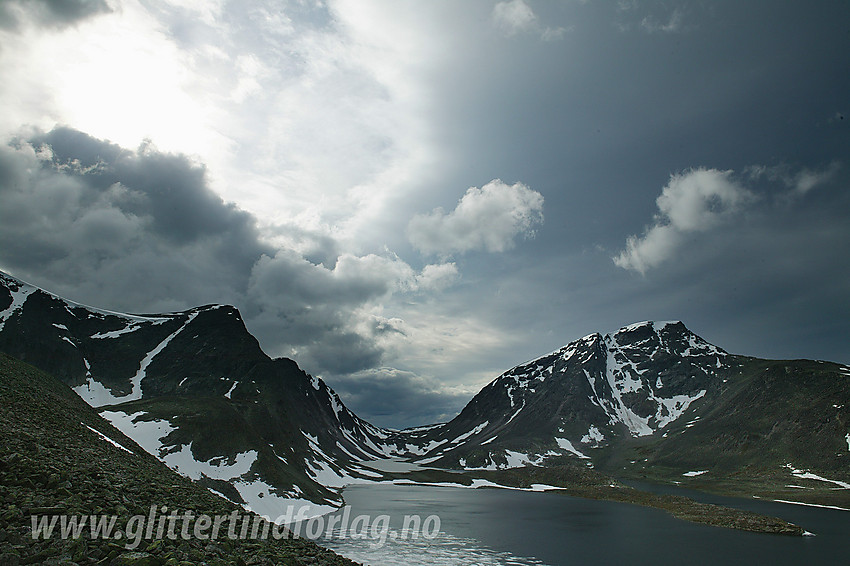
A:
[407, 179, 543, 255]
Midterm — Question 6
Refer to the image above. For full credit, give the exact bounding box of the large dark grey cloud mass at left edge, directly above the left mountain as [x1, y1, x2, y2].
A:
[0, 128, 270, 310]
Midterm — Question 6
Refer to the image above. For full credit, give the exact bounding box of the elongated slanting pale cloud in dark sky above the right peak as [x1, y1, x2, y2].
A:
[614, 168, 754, 273]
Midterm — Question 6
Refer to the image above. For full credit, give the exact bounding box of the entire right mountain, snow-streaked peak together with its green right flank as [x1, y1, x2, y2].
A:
[390, 322, 850, 504]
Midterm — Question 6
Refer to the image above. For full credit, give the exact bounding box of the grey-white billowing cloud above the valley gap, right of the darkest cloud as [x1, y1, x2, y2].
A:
[248, 250, 457, 374]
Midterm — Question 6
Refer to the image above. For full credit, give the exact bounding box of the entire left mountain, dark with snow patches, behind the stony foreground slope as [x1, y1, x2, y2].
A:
[0, 274, 390, 515]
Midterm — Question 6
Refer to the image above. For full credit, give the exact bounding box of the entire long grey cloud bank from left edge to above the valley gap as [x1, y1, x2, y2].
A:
[0, 128, 459, 380]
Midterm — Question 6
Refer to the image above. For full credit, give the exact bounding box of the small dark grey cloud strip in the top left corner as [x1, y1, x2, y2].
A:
[0, 0, 110, 30]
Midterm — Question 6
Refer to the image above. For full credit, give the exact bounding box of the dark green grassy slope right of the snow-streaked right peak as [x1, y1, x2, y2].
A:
[597, 356, 850, 508]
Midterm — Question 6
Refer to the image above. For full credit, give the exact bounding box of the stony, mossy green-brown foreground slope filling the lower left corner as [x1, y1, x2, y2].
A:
[0, 354, 353, 566]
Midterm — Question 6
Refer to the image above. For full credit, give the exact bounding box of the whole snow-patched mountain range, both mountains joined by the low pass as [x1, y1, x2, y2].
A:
[0, 273, 850, 516]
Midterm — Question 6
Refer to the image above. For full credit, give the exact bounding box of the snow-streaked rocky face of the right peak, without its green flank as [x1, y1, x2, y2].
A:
[394, 322, 730, 468]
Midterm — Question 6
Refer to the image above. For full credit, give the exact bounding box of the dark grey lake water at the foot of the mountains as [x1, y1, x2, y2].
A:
[320, 485, 850, 566]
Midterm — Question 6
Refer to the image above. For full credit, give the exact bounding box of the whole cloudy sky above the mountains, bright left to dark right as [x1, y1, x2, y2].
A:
[0, 0, 850, 428]
